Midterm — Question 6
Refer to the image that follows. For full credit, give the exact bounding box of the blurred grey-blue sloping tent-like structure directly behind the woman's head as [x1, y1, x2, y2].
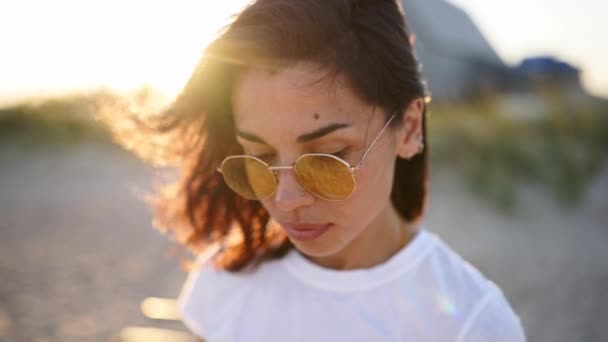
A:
[402, 0, 508, 100]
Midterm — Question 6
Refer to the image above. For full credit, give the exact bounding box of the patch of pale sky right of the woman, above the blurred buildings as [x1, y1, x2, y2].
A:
[450, 0, 608, 98]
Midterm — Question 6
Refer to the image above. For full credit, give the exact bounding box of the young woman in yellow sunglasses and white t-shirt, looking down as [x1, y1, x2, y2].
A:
[107, 0, 525, 342]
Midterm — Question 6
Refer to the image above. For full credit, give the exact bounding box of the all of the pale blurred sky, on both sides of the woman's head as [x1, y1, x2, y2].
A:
[0, 0, 608, 103]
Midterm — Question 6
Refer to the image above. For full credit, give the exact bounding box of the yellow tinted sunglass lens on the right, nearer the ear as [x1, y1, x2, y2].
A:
[295, 155, 355, 200]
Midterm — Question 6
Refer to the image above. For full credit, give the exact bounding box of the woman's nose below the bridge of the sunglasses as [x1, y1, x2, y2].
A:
[274, 169, 315, 212]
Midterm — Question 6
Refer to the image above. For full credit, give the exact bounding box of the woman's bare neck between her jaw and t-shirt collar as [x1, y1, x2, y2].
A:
[309, 205, 418, 270]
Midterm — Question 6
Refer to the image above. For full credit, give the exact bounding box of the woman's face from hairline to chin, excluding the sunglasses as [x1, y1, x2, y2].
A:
[233, 64, 420, 257]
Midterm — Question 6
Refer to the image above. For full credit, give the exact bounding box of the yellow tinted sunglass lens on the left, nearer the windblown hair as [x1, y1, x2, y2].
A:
[222, 157, 277, 200]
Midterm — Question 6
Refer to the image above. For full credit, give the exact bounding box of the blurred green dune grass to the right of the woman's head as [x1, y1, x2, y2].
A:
[429, 96, 608, 211]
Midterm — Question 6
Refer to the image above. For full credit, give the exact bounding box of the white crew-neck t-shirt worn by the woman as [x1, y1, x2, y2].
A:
[178, 229, 526, 342]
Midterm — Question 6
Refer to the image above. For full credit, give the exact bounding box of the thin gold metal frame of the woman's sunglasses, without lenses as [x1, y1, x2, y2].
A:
[217, 112, 398, 201]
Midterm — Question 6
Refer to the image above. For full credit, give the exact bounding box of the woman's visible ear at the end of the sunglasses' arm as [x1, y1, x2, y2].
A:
[397, 97, 424, 159]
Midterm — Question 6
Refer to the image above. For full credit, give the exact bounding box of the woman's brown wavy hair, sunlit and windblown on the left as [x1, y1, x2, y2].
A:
[102, 0, 429, 271]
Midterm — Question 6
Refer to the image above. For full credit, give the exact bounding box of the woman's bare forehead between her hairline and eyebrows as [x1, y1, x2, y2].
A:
[233, 63, 372, 136]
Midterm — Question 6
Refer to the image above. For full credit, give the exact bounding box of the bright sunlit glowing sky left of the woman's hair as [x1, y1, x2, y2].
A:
[0, 0, 247, 101]
